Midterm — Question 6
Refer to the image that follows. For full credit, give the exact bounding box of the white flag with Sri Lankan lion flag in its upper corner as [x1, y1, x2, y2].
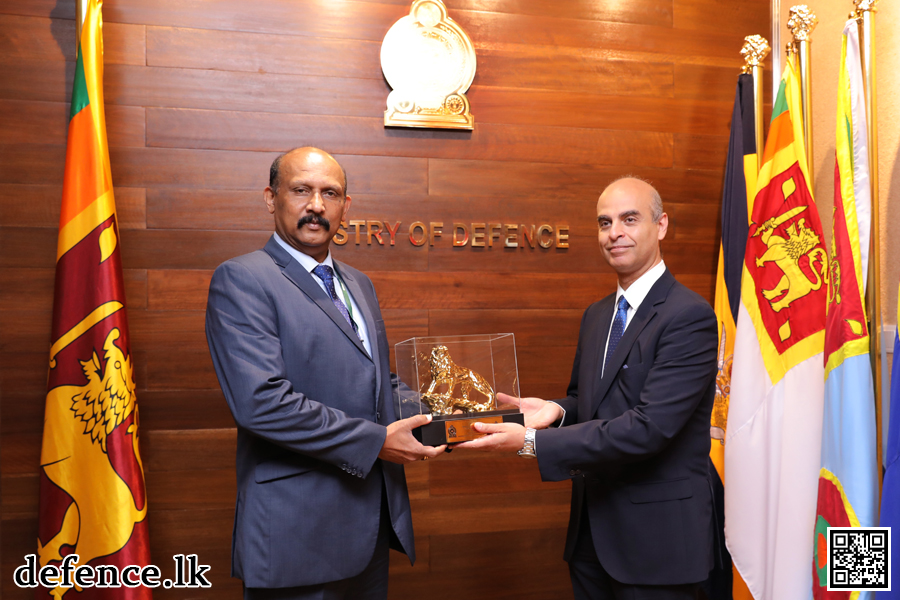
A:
[725, 60, 828, 600]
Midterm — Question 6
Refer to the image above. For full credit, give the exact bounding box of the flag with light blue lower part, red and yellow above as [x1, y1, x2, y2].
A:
[812, 19, 878, 600]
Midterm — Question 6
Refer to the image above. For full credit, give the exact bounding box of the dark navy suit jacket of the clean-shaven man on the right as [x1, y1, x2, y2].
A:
[536, 271, 717, 585]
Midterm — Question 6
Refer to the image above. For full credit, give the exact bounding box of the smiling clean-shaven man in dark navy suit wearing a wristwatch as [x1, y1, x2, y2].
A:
[461, 177, 717, 600]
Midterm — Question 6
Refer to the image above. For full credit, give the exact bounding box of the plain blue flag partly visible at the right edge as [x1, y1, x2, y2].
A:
[875, 284, 900, 600]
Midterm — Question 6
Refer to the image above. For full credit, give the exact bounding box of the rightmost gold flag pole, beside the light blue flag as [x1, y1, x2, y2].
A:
[854, 0, 882, 496]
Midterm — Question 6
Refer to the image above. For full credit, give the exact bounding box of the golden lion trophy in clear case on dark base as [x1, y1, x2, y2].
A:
[395, 333, 525, 446]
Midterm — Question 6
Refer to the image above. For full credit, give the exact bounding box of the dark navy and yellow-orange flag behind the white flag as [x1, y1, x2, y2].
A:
[703, 74, 757, 600]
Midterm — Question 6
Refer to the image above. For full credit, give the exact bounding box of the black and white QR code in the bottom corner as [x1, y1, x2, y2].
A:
[828, 527, 891, 591]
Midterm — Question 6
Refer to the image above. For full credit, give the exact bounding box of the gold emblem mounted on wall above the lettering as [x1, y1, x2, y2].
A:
[381, 0, 475, 129]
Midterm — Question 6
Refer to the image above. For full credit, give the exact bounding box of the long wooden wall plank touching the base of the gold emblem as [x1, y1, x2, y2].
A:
[147, 108, 672, 167]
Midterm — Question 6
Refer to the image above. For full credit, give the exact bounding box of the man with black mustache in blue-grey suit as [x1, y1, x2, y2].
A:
[206, 148, 443, 600]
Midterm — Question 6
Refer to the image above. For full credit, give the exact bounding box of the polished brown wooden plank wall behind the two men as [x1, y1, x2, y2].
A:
[0, 0, 769, 600]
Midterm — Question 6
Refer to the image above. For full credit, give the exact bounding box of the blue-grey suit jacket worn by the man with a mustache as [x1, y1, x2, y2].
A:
[206, 239, 415, 587]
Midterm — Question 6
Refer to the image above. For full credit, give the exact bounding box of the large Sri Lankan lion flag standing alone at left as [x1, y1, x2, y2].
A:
[37, 0, 151, 600]
